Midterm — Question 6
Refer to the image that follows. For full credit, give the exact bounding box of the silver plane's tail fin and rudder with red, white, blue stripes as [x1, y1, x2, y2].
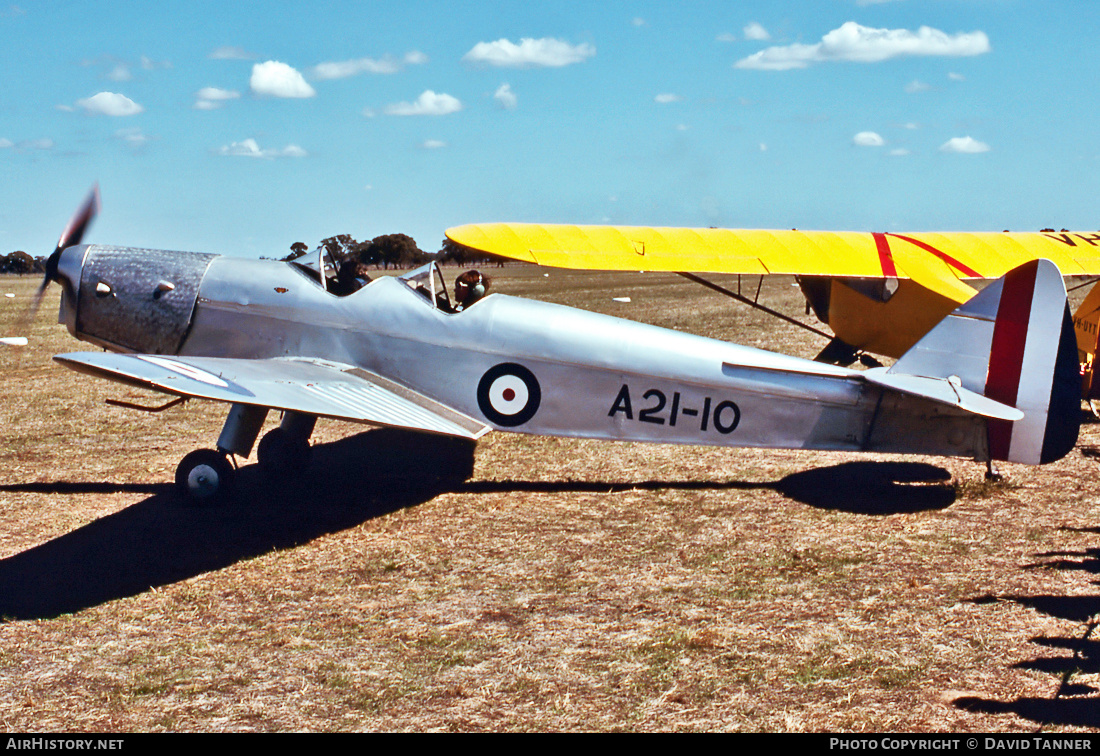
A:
[889, 260, 1081, 464]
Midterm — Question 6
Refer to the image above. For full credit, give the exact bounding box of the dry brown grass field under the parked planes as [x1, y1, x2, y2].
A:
[0, 267, 1100, 732]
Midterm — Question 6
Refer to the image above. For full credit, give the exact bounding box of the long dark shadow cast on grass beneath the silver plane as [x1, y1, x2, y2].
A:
[0, 429, 955, 620]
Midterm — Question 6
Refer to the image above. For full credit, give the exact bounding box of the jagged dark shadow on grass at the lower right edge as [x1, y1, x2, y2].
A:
[954, 528, 1100, 727]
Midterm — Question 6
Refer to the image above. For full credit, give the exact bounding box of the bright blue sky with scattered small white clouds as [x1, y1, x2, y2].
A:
[0, 0, 1100, 256]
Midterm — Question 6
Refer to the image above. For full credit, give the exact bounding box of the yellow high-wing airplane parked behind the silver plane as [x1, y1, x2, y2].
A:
[447, 223, 1100, 398]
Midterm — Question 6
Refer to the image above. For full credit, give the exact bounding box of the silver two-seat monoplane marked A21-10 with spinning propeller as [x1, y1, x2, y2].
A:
[25, 190, 1080, 500]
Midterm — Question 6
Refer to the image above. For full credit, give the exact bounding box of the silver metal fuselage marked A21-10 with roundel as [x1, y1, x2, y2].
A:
[59, 245, 986, 457]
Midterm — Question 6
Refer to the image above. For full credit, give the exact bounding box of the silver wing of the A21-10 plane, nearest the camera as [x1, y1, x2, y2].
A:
[54, 352, 491, 439]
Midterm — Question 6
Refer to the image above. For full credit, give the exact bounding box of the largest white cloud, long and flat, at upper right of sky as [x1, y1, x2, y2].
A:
[734, 21, 990, 70]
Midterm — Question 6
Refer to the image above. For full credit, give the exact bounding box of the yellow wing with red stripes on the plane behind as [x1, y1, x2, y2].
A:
[447, 223, 1100, 281]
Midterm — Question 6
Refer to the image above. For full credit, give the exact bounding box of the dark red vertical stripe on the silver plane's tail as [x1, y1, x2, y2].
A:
[986, 261, 1038, 460]
